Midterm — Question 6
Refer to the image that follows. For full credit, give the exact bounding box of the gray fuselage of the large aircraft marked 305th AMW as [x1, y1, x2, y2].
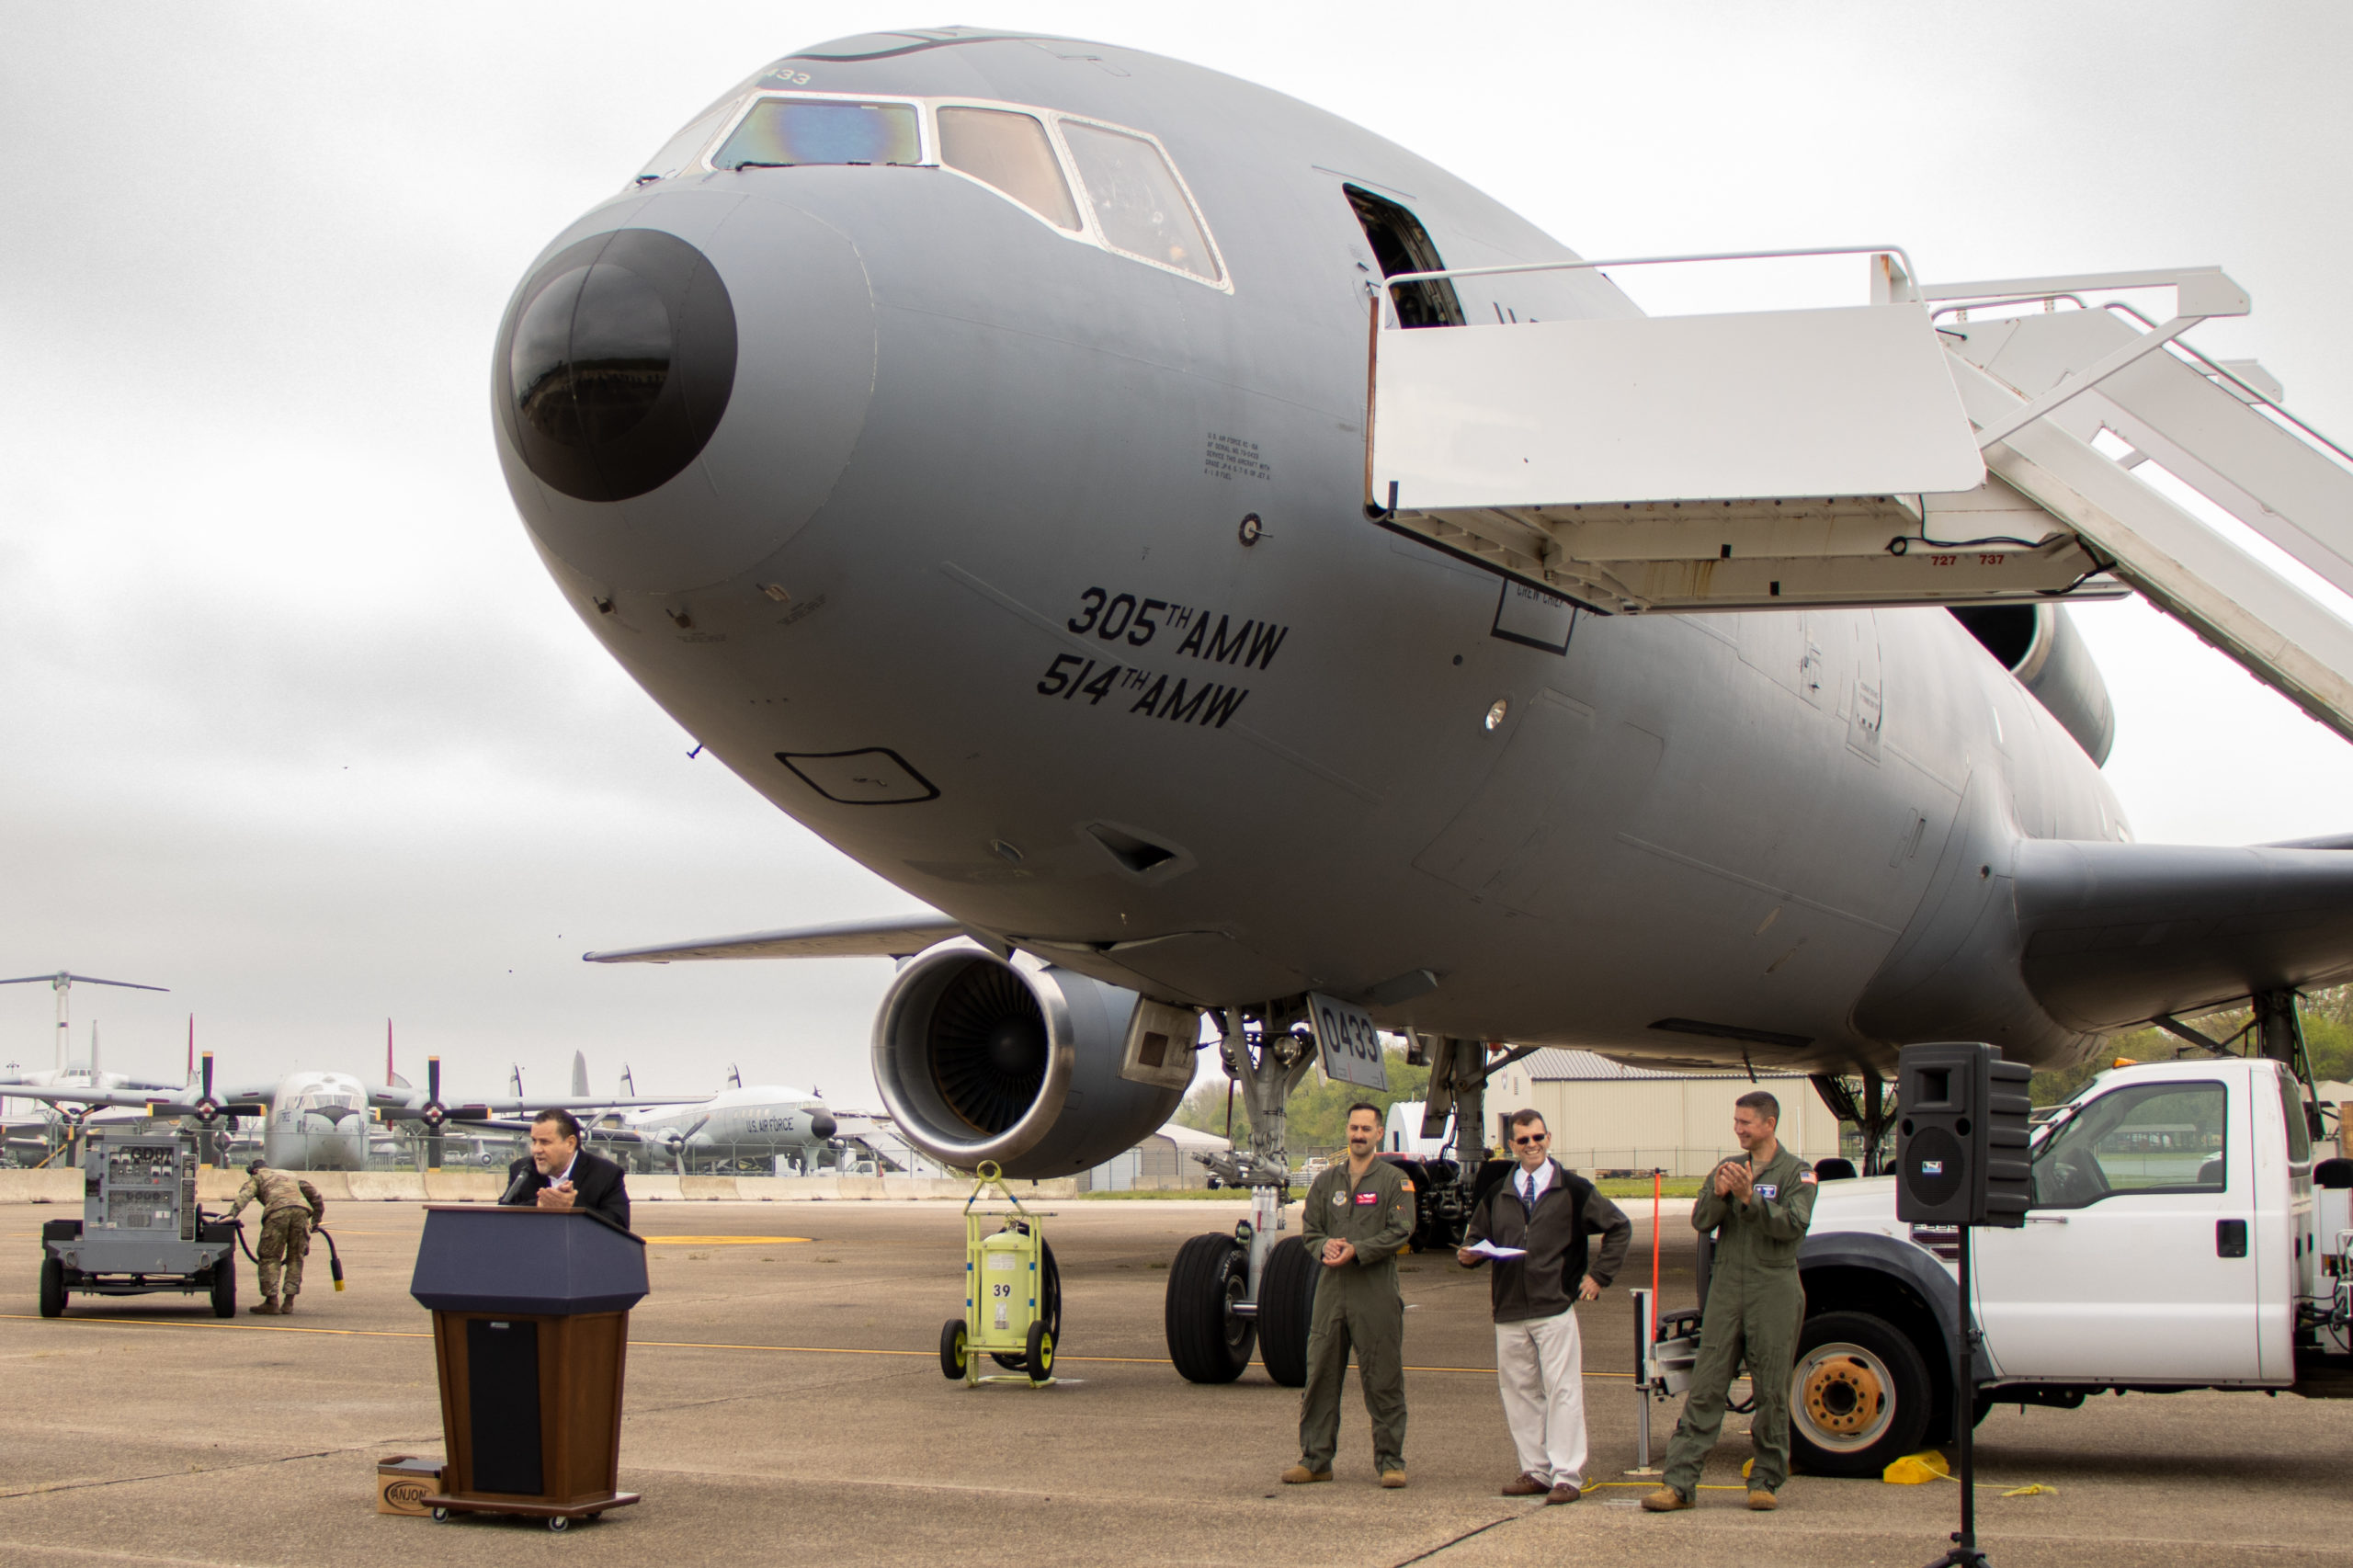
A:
[496, 40, 2125, 1074]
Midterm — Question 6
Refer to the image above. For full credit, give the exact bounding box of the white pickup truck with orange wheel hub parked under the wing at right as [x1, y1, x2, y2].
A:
[1790, 1057, 2353, 1476]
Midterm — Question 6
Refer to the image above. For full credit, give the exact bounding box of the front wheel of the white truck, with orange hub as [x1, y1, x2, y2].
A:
[1789, 1312, 1934, 1476]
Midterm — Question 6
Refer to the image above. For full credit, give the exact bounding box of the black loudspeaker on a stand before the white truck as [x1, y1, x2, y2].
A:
[1896, 1043, 2033, 1227]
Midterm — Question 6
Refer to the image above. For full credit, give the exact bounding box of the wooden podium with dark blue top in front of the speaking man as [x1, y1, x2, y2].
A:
[409, 1203, 647, 1530]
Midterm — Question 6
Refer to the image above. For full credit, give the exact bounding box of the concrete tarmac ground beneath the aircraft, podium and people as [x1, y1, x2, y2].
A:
[0, 1200, 2353, 1568]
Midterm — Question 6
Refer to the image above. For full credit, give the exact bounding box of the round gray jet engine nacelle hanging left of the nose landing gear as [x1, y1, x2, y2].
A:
[873, 942, 1184, 1179]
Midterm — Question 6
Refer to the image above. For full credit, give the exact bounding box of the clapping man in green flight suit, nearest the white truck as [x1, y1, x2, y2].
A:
[1643, 1090, 1816, 1514]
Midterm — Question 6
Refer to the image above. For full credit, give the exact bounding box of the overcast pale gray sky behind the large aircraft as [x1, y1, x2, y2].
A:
[0, 0, 2353, 1104]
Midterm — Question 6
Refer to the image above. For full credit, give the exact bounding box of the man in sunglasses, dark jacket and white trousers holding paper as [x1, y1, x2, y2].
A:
[1454, 1111, 1633, 1505]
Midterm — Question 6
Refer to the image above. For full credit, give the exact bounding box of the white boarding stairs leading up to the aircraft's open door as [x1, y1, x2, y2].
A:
[1365, 247, 2353, 739]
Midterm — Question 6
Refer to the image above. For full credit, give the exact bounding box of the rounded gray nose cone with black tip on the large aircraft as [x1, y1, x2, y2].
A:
[492, 190, 875, 594]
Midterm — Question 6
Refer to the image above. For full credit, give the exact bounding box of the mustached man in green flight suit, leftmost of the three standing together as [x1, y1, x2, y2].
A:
[1282, 1099, 1415, 1488]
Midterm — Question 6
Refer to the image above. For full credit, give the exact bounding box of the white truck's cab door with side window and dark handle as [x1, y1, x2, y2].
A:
[1974, 1078, 2261, 1382]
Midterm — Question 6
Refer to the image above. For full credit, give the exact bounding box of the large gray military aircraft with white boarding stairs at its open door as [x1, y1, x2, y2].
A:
[492, 28, 2353, 1378]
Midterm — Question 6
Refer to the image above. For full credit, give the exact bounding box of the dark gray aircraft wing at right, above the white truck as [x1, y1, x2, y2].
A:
[2017, 838, 2353, 1034]
